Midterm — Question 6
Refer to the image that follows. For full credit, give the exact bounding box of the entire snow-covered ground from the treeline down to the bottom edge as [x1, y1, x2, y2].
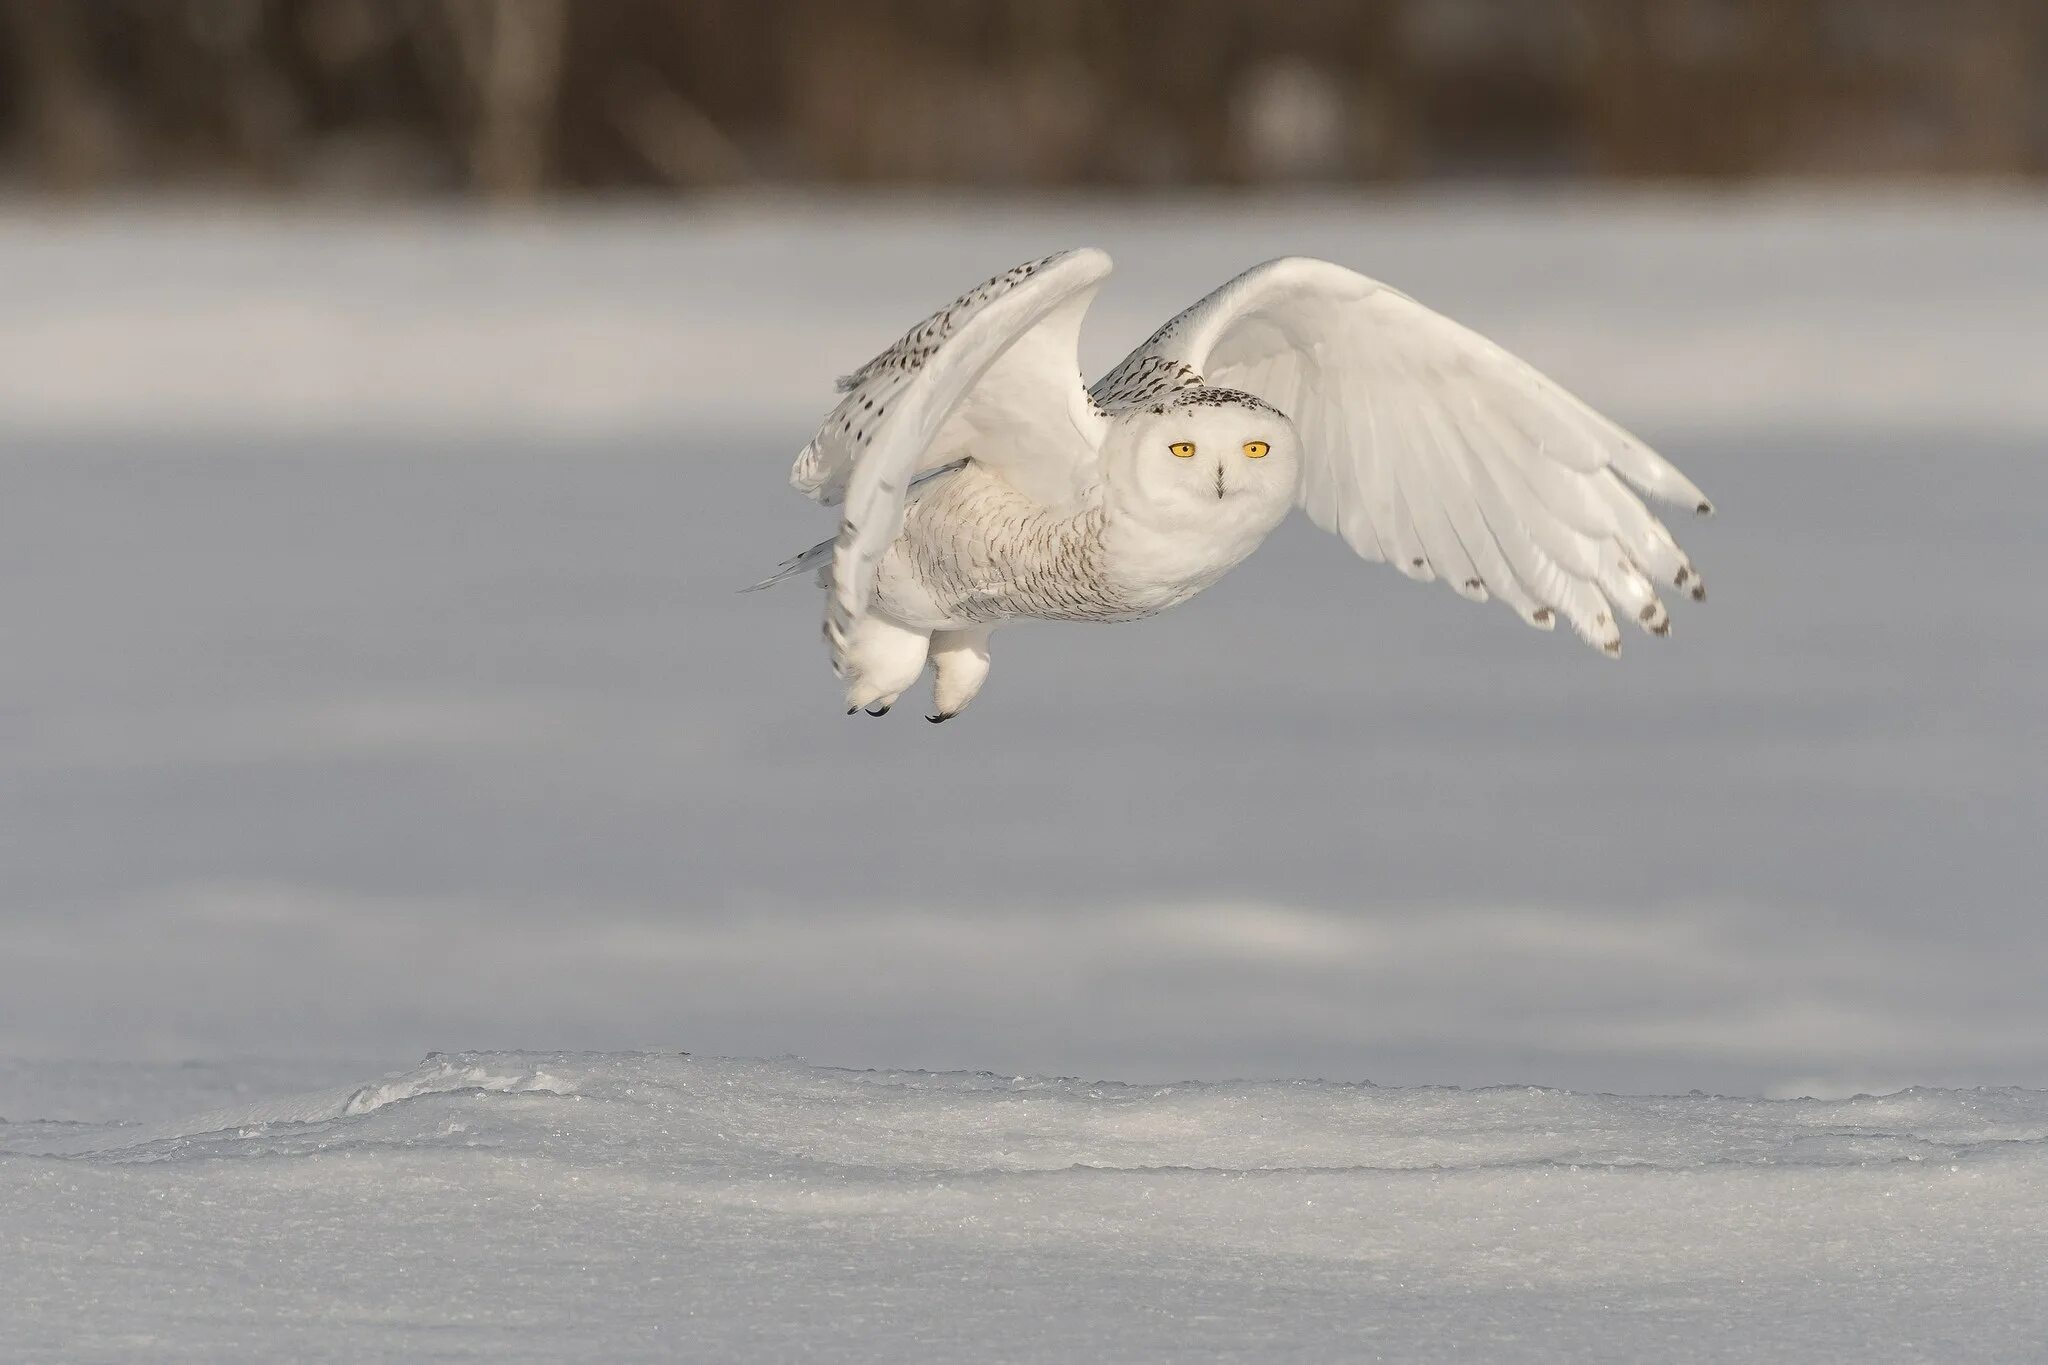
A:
[0, 196, 2048, 1361]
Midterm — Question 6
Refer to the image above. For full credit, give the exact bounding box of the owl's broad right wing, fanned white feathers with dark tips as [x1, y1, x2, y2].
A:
[1098, 256, 1710, 655]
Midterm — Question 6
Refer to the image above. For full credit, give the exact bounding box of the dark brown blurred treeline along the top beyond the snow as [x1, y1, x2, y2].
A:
[0, 0, 2048, 199]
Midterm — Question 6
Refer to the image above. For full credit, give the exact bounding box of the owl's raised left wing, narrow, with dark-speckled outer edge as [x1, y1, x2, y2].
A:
[791, 248, 1110, 667]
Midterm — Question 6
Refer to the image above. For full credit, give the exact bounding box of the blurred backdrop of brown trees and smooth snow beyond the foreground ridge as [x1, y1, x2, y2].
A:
[0, 0, 2048, 1117]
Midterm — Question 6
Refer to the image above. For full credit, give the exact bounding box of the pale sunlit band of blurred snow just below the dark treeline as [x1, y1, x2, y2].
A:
[12, 188, 2048, 439]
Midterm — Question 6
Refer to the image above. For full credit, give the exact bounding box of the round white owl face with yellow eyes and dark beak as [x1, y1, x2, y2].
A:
[1104, 389, 1300, 522]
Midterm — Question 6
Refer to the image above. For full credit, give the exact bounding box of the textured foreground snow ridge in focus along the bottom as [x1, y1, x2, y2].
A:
[0, 1052, 2048, 1361]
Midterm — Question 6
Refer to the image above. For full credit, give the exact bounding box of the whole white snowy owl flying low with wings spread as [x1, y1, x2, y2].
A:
[756, 248, 1710, 722]
